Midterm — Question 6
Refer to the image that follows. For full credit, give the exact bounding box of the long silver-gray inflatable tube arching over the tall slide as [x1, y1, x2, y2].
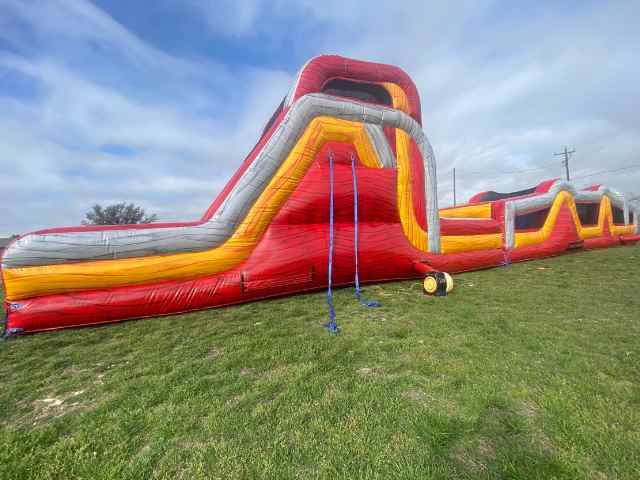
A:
[2, 94, 440, 268]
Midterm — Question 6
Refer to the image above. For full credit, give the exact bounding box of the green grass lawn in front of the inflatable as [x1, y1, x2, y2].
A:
[0, 248, 640, 479]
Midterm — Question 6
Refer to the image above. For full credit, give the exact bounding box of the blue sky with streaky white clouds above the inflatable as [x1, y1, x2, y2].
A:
[0, 0, 640, 233]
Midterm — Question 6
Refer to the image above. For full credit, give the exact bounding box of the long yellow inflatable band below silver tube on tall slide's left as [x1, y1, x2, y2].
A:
[3, 117, 382, 301]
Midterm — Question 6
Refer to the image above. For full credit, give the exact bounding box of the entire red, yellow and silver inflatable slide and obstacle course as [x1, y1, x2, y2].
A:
[2, 55, 640, 334]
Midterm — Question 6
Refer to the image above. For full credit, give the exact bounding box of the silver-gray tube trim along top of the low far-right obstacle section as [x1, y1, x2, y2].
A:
[504, 180, 638, 250]
